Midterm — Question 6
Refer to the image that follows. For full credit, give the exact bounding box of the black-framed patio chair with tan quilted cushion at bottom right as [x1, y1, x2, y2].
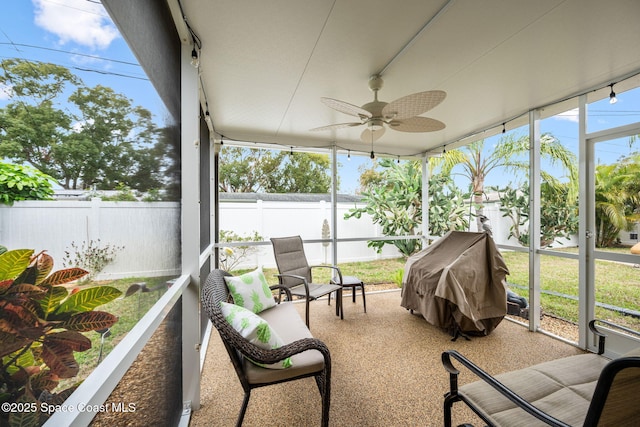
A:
[442, 321, 640, 427]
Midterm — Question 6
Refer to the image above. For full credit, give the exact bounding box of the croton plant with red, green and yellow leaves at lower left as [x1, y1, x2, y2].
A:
[0, 247, 121, 426]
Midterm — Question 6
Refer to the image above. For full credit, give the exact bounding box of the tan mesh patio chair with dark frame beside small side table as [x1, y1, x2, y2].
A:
[271, 236, 343, 327]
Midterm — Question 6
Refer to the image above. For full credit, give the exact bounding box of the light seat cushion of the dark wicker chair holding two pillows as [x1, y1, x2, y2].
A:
[244, 302, 324, 384]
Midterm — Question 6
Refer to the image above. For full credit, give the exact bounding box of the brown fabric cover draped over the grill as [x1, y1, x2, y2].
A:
[401, 231, 509, 335]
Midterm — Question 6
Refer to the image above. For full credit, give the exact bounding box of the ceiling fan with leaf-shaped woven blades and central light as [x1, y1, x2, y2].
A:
[311, 75, 447, 142]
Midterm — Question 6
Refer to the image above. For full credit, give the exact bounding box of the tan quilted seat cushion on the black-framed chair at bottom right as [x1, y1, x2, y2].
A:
[460, 353, 608, 427]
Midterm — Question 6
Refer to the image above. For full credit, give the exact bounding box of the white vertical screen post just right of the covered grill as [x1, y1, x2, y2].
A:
[529, 110, 540, 331]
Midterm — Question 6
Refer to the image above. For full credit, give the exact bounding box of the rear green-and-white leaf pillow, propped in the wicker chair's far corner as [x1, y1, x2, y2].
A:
[224, 268, 276, 314]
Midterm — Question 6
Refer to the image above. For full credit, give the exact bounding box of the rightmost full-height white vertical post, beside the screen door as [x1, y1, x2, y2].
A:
[578, 95, 596, 349]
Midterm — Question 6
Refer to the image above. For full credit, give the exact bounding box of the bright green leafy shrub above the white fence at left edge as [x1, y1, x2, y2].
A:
[0, 162, 54, 206]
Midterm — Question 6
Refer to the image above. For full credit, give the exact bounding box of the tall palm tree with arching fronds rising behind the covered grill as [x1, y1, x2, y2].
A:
[431, 134, 578, 230]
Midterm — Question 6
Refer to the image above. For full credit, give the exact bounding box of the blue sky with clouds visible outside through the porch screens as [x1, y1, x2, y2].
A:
[0, 0, 640, 194]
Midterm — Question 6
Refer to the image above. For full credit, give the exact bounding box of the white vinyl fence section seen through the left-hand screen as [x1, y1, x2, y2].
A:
[0, 199, 180, 279]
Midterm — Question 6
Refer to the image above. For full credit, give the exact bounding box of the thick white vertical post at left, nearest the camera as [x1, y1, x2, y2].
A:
[180, 44, 201, 411]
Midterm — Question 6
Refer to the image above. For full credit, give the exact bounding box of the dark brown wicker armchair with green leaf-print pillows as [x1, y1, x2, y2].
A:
[201, 270, 331, 427]
